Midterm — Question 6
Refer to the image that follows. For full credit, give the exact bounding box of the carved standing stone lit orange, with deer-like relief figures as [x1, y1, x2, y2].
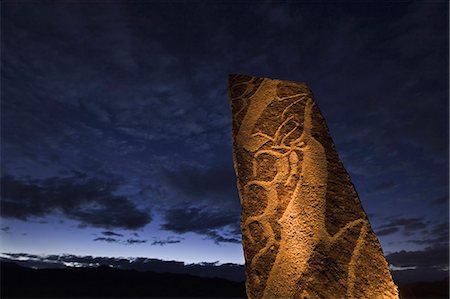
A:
[229, 75, 398, 298]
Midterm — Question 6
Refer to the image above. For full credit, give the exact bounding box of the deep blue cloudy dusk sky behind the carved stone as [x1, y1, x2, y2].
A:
[0, 1, 449, 284]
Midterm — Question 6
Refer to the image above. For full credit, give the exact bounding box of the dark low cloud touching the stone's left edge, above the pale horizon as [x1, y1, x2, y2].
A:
[161, 206, 241, 243]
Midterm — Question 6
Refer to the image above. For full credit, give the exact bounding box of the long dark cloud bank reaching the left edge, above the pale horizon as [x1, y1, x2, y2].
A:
[0, 173, 151, 229]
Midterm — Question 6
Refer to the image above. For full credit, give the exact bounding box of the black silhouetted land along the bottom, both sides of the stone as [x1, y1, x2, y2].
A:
[0, 262, 449, 298]
